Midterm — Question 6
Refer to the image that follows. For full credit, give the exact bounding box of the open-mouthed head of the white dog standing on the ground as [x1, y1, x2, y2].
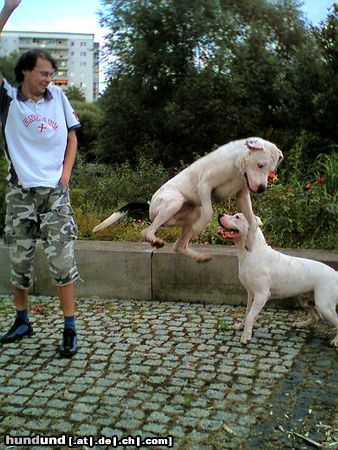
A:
[218, 213, 263, 246]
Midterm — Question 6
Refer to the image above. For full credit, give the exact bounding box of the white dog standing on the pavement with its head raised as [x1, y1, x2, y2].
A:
[218, 213, 338, 347]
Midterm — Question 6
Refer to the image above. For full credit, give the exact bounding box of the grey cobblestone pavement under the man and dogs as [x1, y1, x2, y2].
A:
[0, 297, 338, 450]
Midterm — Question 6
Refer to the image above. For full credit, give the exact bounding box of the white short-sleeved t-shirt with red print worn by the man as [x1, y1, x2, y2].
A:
[0, 80, 80, 189]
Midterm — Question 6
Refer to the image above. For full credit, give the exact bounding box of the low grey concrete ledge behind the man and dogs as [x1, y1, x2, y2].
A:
[0, 241, 338, 305]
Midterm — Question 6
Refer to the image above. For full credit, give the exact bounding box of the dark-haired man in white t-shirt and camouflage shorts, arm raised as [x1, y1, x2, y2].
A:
[0, 0, 80, 357]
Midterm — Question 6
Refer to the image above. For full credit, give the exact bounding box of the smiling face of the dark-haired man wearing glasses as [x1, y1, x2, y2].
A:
[23, 58, 54, 96]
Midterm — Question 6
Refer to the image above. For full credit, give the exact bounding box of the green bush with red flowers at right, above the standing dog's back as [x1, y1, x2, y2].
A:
[253, 153, 337, 249]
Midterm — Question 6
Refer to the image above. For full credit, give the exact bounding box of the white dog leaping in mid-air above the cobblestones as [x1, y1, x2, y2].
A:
[93, 138, 283, 261]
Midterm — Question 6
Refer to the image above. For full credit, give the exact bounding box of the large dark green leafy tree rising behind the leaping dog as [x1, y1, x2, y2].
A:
[98, 0, 332, 166]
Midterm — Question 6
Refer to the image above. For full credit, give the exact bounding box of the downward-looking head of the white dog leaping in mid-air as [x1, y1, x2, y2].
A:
[236, 138, 283, 194]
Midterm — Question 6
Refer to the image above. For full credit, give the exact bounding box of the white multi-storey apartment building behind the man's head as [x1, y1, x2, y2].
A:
[0, 31, 100, 102]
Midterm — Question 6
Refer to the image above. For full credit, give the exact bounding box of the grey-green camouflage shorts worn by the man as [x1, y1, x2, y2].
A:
[4, 183, 79, 289]
